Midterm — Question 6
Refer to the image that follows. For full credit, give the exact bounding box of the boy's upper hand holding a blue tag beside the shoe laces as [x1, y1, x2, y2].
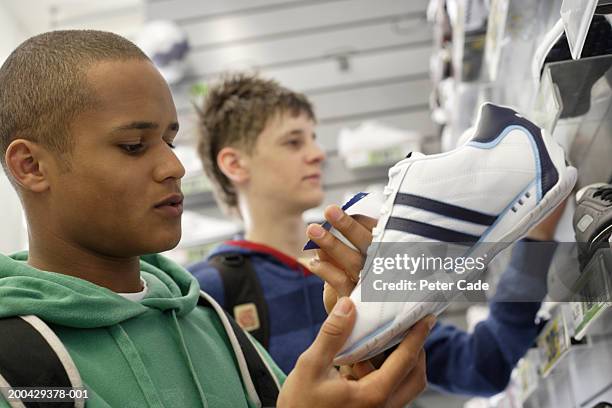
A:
[307, 205, 377, 313]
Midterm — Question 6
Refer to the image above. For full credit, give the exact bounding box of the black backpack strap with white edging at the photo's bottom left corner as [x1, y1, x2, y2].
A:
[0, 315, 85, 408]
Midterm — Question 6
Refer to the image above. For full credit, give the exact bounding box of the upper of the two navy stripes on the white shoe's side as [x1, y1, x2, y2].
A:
[394, 193, 497, 226]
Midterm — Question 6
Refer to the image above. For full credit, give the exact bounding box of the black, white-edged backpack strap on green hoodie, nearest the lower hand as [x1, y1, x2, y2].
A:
[198, 291, 281, 408]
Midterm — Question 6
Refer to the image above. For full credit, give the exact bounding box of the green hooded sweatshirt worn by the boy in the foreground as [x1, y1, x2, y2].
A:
[0, 253, 284, 408]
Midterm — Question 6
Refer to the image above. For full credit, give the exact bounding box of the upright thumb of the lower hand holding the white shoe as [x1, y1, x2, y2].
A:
[296, 297, 355, 378]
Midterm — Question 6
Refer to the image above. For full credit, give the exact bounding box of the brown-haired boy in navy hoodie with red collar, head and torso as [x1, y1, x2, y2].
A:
[189, 76, 326, 372]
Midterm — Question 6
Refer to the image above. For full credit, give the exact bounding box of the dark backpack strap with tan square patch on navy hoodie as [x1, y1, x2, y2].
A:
[208, 252, 270, 350]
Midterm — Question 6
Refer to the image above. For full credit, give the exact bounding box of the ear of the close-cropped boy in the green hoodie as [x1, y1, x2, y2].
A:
[5, 139, 49, 193]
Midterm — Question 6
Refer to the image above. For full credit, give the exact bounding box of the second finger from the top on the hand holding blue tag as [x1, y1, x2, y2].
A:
[306, 224, 364, 276]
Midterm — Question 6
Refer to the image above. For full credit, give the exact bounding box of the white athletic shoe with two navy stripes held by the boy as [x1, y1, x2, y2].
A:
[335, 103, 576, 365]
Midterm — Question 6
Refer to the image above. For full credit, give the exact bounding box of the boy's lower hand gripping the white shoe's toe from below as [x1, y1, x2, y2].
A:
[278, 297, 435, 408]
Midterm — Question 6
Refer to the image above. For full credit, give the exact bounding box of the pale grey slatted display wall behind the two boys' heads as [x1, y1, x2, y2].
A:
[146, 0, 435, 234]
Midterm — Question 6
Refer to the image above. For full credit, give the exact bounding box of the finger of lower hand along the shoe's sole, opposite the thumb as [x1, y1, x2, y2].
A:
[363, 315, 435, 394]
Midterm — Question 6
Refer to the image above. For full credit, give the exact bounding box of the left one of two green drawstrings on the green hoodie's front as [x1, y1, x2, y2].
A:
[108, 324, 164, 408]
